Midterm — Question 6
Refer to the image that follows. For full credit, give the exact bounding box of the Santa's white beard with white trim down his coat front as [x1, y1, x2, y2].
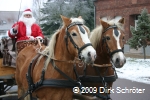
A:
[19, 16, 36, 36]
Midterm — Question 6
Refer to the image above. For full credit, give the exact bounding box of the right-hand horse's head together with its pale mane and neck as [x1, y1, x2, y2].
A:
[90, 18, 126, 68]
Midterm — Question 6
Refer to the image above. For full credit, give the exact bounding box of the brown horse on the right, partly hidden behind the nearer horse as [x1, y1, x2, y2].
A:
[75, 18, 126, 100]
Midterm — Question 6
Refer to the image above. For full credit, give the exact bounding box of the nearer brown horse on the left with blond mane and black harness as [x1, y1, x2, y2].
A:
[15, 16, 96, 100]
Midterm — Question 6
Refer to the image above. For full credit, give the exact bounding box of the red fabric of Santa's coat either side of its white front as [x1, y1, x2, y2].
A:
[8, 21, 44, 41]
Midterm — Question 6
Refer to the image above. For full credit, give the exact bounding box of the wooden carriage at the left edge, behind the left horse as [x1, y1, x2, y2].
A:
[0, 38, 17, 100]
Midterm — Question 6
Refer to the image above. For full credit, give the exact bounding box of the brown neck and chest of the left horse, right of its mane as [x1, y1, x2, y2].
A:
[50, 29, 74, 78]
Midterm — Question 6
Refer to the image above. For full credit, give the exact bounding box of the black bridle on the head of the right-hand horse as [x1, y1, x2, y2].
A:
[102, 25, 124, 58]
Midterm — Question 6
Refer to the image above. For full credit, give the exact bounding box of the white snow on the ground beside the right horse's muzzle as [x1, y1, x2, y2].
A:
[116, 57, 150, 84]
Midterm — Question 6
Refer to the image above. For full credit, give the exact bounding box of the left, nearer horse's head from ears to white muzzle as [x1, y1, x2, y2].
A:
[61, 16, 96, 63]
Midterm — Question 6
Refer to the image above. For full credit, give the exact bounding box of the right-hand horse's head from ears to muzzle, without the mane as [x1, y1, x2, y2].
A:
[100, 18, 126, 68]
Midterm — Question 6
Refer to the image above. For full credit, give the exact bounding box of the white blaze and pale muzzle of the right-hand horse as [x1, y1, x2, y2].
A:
[112, 30, 126, 68]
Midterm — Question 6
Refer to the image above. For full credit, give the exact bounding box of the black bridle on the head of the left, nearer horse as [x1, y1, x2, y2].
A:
[65, 22, 92, 59]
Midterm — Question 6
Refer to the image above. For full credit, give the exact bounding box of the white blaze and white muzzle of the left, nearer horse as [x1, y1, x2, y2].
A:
[78, 26, 96, 63]
